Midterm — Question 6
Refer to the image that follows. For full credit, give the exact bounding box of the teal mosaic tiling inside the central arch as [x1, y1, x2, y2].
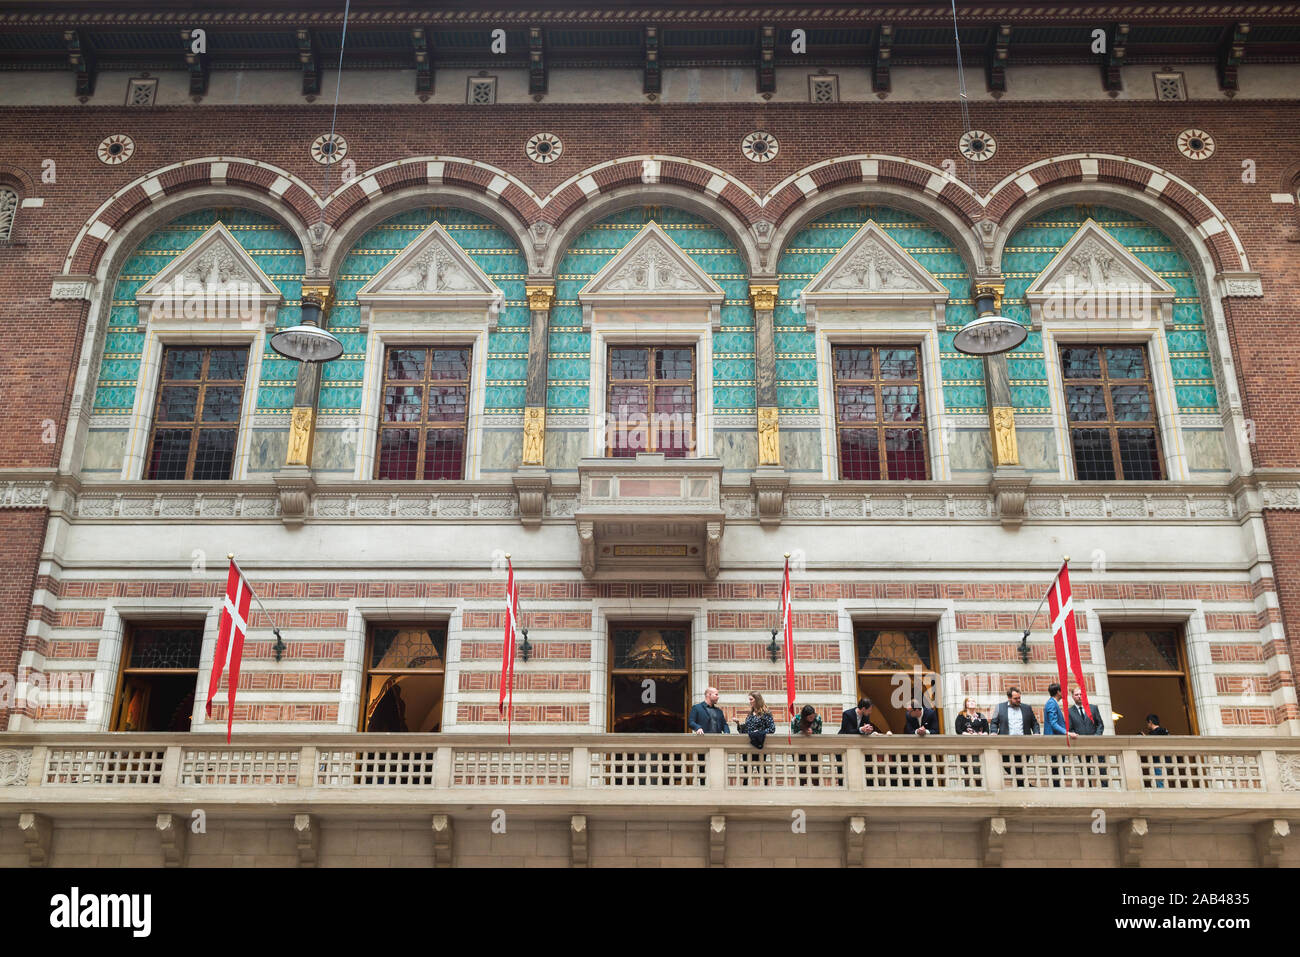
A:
[546, 207, 755, 412]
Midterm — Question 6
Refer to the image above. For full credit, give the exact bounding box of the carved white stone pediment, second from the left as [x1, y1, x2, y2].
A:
[356, 222, 504, 325]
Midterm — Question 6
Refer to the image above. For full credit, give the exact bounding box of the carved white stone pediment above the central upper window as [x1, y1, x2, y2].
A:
[577, 222, 727, 326]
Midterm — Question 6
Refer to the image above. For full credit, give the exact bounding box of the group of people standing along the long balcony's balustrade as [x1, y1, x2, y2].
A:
[688, 681, 1169, 748]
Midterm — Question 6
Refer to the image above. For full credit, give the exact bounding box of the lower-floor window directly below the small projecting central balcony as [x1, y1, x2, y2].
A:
[610, 624, 690, 733]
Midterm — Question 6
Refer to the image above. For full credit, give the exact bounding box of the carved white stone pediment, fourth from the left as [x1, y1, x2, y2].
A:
[801, 221, 950, 328]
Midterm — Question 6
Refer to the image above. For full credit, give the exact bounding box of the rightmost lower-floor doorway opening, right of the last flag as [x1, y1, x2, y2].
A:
[1101, 625, 1200, 735]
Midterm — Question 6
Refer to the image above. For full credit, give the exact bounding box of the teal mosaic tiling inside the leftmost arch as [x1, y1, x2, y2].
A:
[95, 207, 304, 412]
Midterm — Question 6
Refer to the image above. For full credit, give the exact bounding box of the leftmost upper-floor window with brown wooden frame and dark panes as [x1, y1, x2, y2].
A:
[144, 346, 248, 479]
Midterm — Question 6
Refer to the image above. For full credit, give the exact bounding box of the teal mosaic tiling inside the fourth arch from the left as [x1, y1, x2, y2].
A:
[772, 205, 984, 412]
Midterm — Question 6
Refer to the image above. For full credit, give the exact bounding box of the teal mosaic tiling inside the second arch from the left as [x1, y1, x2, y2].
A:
[340, 207, 532, 412]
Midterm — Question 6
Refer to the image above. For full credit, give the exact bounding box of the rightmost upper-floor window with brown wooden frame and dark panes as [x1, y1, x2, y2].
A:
[1061, 346, 1162, 481]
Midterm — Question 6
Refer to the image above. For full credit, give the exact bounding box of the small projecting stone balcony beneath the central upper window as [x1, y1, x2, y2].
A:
[573, 452, 725, 579]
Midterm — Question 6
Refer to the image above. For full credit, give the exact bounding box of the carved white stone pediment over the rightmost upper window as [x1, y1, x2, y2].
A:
[1024, 218, 1177, 328]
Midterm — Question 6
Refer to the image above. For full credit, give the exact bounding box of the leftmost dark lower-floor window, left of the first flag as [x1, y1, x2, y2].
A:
[113, 624, 203, 731]
